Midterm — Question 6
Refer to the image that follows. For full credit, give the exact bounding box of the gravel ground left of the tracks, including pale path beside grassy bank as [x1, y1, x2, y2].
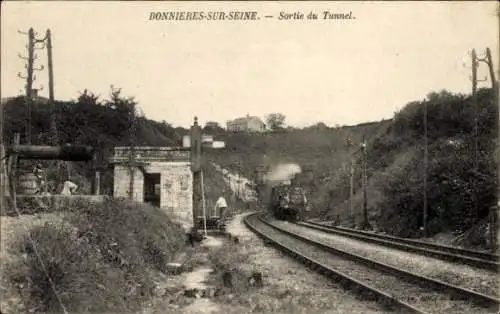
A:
[143, 214, 385, 314]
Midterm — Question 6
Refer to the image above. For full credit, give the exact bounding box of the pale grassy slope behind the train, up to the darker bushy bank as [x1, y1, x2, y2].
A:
[208, 120, 391, 214]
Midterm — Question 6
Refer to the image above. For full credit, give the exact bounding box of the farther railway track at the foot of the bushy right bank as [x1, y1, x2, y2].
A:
[298, 222, 500, 272]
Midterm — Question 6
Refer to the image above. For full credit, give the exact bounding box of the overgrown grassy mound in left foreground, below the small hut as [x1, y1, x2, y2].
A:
[3, 200, 185, 312]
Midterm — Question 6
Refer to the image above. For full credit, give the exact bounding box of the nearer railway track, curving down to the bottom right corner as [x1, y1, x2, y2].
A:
[245, 214, 499, 313]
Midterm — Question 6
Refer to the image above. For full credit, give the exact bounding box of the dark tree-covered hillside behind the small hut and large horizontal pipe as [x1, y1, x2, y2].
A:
[4, 88, 187, 194]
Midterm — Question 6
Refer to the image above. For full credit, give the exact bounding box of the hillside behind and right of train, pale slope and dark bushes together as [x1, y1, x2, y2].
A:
[209, 89, 498, 243]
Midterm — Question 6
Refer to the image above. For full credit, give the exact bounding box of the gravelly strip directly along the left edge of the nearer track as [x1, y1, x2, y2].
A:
[217, 213, 385, 314]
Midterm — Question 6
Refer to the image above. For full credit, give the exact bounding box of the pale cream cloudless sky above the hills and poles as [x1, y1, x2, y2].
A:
[1, 1, 500, 127]
